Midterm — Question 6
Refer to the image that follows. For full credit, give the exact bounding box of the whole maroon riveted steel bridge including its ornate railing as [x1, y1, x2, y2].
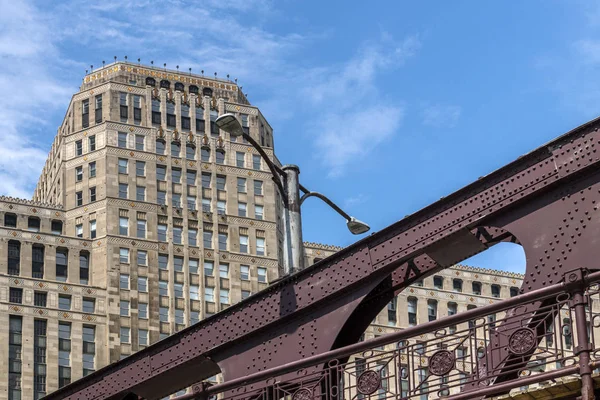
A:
[45, 115, 600, 400]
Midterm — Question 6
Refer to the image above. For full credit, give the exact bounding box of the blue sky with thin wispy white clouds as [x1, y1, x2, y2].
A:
[0, 0, 600, 271]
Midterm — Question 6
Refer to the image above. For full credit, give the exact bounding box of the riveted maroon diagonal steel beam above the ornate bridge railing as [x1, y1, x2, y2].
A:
[47, 116, 600, 400]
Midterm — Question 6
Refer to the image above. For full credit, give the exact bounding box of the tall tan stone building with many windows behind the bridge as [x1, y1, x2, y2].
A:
[0, 62, 522, 399]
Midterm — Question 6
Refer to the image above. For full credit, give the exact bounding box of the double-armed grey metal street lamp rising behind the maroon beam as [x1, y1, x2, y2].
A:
[215, 114, 370, 275]
